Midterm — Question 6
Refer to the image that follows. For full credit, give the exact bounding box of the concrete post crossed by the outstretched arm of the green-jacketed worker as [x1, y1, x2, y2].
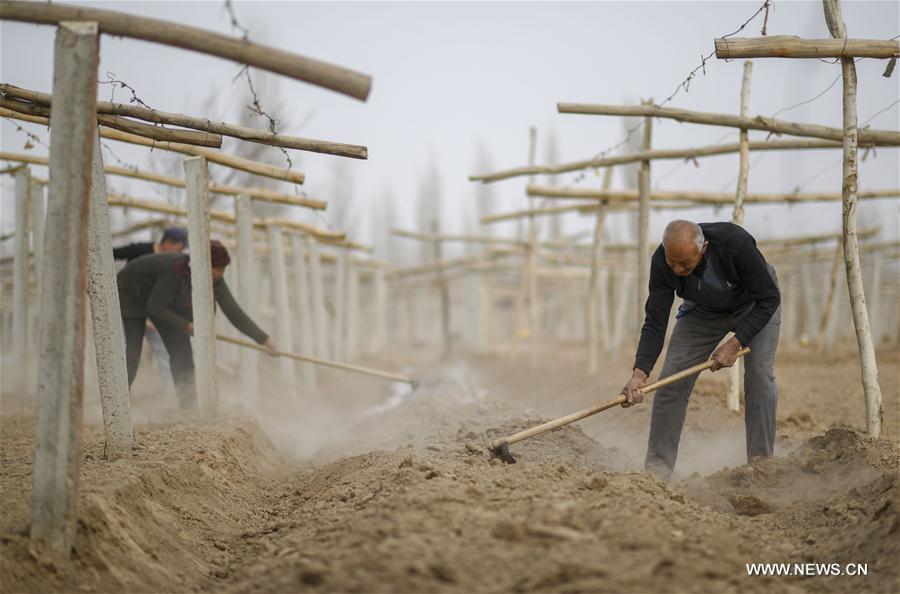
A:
[234, 194, 259, 406]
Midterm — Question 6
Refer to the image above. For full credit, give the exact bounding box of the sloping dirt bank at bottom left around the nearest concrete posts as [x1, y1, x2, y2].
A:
[0, 417, 285, 592]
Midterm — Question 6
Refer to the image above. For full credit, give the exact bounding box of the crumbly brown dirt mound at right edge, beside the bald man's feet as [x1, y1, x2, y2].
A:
[682, 428, 900, 591]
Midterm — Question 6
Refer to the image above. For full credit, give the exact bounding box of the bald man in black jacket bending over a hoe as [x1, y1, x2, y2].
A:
[622, 221, 781, 480]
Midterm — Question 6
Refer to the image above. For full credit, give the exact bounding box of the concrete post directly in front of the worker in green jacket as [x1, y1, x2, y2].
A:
[184, 157, 218, 415]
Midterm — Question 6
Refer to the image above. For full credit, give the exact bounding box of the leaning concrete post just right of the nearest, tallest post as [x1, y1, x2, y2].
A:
[87, 130, 134, 458]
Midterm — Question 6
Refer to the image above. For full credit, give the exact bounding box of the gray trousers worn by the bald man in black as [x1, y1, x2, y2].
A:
[644, 265, 781, 480]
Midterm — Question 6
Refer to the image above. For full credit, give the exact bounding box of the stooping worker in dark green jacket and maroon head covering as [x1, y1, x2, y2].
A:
[117, 240, 276, 409]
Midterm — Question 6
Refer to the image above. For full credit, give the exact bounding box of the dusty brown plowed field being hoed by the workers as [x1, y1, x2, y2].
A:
[0, 338, 900, 593]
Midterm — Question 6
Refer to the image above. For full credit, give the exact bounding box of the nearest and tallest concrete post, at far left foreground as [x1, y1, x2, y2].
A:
[31, 22, 100, 554]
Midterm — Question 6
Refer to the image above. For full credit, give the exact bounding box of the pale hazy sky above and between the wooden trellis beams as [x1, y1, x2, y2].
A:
[0, 0, 900, 248]
